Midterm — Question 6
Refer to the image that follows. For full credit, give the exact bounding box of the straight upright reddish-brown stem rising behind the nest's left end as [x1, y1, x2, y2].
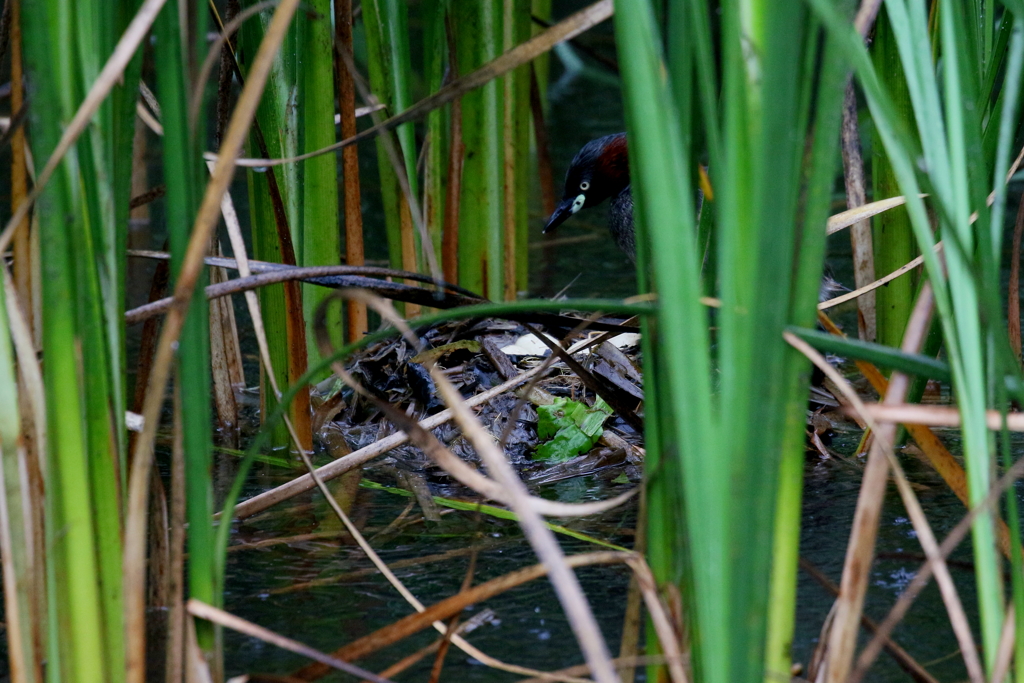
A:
[334, 0, 370, 341]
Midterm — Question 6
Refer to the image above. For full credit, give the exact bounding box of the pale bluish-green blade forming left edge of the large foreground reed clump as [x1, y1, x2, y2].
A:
[615, 2, 716, 680]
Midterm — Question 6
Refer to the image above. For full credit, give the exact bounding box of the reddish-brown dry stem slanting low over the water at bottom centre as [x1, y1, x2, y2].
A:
[293, 550, 632, 681]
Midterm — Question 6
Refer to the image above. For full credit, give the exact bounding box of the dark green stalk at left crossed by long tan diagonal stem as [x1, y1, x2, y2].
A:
[156, 3, 214, 651]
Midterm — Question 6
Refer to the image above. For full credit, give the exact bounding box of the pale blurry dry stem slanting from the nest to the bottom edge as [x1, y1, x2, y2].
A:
[430, 365, 614, 683]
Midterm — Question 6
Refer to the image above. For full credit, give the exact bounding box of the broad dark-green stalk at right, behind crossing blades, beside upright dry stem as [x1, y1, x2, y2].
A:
[871, 8, 918, 348]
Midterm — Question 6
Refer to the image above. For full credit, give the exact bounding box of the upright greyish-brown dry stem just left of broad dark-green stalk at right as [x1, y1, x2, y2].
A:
[842, 78, 874, 341]
